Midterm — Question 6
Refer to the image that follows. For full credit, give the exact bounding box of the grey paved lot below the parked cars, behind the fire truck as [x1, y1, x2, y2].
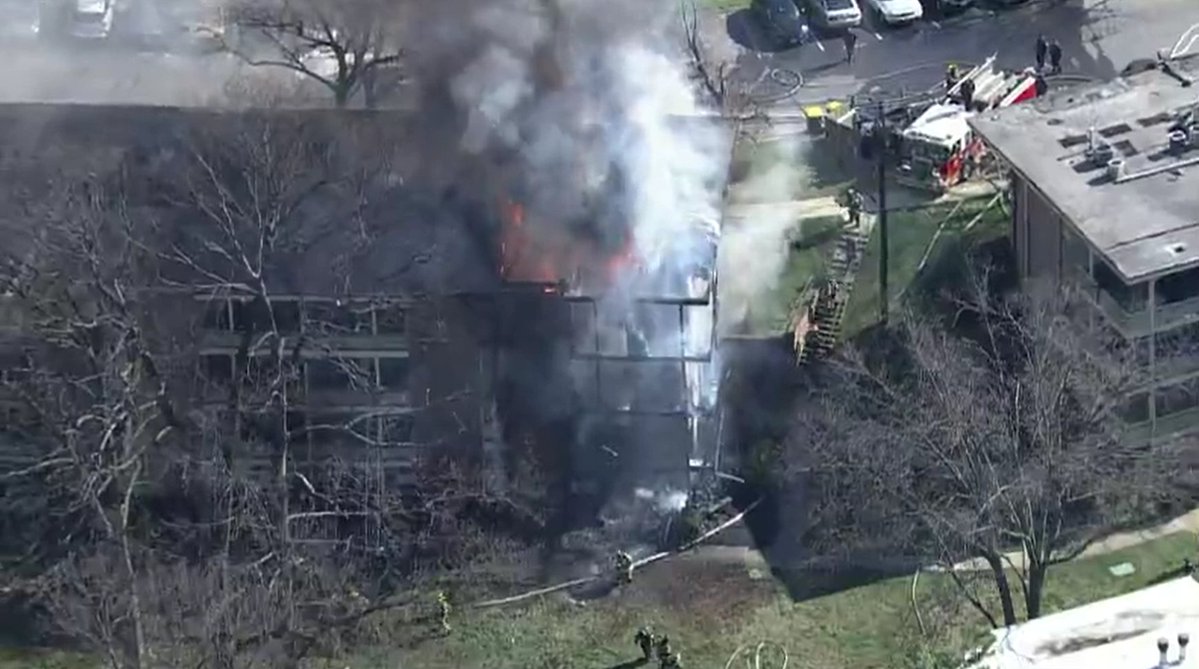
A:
[712, 0, 1199, 100]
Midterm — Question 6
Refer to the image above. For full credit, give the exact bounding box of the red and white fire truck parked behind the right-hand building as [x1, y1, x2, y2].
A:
[897, 55, 1044, 192]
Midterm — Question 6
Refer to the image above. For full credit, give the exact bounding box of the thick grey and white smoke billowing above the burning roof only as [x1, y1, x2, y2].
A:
[410, 0, 728, 293]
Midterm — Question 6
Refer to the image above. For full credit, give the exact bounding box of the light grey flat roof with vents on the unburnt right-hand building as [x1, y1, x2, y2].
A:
[969, 61, 1199, 283]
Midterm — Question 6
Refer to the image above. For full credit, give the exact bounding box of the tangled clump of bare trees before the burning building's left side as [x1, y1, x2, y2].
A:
[0, 114, 525, 669]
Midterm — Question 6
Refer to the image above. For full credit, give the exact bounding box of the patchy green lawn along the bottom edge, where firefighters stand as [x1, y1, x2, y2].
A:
[7, 534, 1194, 669]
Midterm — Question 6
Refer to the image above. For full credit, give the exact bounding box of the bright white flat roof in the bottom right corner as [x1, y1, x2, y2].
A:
[971, 577, 1199, 669]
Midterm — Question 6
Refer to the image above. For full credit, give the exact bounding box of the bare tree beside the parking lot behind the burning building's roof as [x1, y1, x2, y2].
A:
[223, 0, 404, 108]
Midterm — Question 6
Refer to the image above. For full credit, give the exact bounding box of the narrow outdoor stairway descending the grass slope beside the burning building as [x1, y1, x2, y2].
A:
[799, 220, 874, 364]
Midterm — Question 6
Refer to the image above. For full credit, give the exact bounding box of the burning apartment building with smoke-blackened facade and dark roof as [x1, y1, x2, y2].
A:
[0, 106, 722, 541]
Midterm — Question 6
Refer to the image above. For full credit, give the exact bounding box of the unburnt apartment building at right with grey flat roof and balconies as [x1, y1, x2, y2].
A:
[970, 62, 1199, 446]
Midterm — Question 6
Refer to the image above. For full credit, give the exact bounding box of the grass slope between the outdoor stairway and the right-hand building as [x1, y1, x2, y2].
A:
[842, 195, 1008, 339]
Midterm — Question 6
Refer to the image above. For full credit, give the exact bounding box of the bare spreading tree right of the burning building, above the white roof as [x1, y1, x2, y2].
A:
[789, 274, 1177, 625]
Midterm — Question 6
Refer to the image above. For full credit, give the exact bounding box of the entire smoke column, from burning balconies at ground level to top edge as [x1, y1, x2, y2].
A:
[409, 0, 729, 520]
